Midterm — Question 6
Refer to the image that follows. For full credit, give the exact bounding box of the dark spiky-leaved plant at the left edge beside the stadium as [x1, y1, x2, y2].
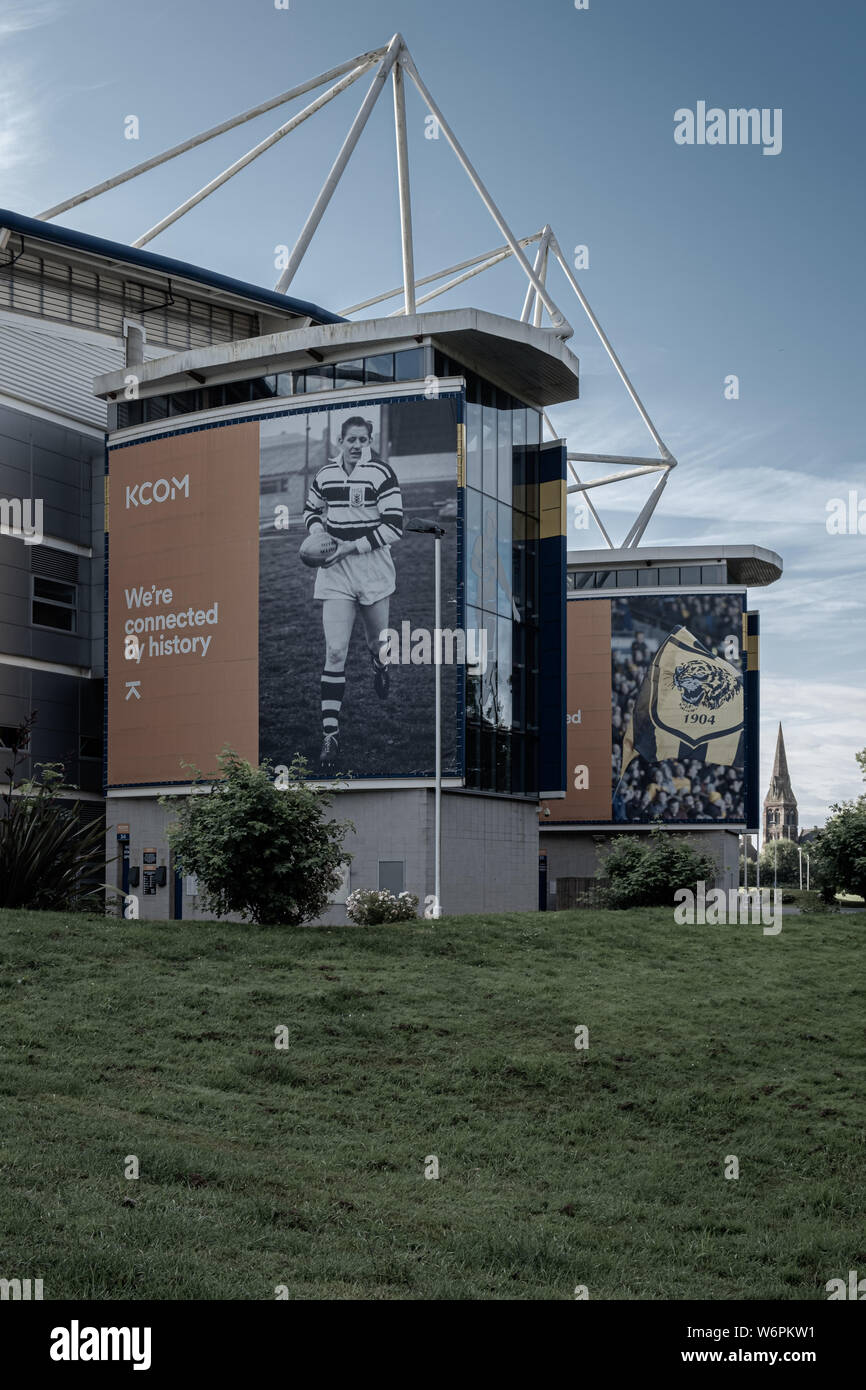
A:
[0, 714, 106, 912]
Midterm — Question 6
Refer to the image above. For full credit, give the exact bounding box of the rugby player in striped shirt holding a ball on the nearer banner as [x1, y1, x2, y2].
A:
[304, 416, 403, 767]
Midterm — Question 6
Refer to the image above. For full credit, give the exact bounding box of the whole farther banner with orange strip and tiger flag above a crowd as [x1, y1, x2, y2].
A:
[545, 594, 753, 826]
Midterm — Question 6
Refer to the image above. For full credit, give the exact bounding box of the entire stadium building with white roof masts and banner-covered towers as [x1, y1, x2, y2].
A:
[0, 35, 781, 922]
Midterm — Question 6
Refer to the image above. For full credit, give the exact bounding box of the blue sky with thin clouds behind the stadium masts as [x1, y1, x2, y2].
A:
[0, 0, 866, 826]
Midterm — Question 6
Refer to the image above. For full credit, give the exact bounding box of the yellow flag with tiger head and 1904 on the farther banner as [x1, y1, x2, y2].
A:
[621, 627, 744, 773]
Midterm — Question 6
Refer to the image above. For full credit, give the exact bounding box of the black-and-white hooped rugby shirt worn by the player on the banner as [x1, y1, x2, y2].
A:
[303, 455, 403, 555]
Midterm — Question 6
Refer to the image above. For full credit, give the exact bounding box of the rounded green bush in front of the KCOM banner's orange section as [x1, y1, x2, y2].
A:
[161, 748, 354, 926]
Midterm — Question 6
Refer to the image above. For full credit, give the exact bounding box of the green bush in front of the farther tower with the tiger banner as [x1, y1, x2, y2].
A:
[601, 828, 719, 908]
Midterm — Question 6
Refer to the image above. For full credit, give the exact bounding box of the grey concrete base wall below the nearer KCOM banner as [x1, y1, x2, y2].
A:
[106, 788, 538, 924]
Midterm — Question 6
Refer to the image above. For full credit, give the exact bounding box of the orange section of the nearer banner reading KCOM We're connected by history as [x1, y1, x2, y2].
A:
[107, 423, 259, 787]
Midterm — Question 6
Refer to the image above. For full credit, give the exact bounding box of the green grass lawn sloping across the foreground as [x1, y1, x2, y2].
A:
[0, 910, 866, 1300]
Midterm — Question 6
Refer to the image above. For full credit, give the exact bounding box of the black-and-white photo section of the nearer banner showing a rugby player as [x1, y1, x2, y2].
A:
[259, 396, 466, 778]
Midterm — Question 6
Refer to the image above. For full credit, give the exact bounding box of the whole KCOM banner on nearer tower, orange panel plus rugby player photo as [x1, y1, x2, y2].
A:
[108, 395, 464, 787]
